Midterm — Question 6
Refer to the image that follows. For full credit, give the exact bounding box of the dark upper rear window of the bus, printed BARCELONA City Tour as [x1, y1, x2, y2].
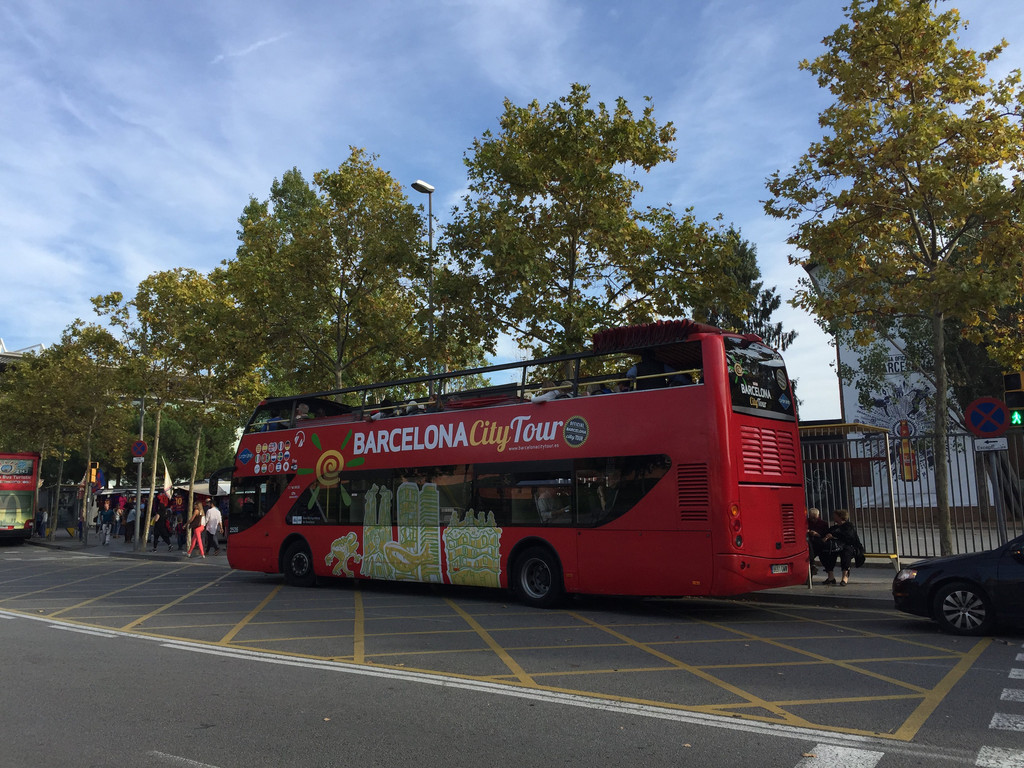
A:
[725, 337, 796, 421]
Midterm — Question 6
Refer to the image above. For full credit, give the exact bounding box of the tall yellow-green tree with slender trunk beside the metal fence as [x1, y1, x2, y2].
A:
[765, 0, 1024, 554]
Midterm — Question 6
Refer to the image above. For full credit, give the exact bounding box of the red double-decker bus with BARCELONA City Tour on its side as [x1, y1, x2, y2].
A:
[227, 319, 807, 606]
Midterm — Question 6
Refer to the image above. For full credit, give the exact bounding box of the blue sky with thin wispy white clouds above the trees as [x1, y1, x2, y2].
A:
[0, 0, 1024, 420]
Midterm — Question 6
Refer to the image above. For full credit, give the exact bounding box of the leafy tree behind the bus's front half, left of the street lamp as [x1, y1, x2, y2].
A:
[215, 147, 429, 393]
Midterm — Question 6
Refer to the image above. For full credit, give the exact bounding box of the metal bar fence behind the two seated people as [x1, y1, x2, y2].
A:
[801, 424, 1024, 564]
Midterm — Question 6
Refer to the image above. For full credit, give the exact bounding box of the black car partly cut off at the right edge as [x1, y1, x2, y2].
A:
[893, 536, 1024, 635]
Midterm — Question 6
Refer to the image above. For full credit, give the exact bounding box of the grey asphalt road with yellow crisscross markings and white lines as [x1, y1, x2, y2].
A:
[0, 547, 1024, 768]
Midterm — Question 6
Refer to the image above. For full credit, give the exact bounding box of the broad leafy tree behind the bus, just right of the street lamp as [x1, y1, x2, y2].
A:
[441, 84, 748, 354]
